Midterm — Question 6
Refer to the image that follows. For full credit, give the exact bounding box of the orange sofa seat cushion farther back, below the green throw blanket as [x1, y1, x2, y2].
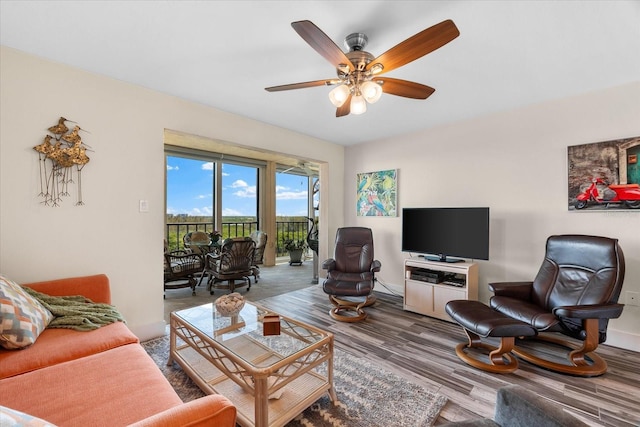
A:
[0, 322, 138, 379]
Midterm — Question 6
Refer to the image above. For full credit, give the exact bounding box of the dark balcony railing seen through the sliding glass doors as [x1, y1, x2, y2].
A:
[165, 221, 311, 256]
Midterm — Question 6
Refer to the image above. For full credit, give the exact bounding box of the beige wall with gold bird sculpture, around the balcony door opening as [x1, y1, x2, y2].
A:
[0, 47, 344, 338]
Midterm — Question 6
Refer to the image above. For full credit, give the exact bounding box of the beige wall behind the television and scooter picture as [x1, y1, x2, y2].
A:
[345, 82, 640, 351]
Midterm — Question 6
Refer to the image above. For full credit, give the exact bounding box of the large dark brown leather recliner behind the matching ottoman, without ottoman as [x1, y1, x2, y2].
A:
[489, 235, 625, 376]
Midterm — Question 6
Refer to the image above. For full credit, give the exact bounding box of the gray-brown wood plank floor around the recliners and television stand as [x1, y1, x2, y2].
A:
[260, 285, 640, 426]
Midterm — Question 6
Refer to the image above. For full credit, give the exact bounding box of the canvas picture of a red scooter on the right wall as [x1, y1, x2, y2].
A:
[567, 136, 640, 212]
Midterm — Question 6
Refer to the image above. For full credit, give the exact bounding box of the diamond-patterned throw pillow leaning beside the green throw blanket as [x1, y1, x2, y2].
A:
[0, 274, 53, 350]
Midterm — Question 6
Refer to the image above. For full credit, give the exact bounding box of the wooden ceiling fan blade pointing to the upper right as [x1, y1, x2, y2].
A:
[366, 19, 460, 73]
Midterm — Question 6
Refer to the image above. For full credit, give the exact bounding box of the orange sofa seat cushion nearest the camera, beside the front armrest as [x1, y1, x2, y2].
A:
[0, 344, 182, 427]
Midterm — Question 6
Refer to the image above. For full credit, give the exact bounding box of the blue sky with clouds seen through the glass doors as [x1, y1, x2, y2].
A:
[167, 156, 308, 216]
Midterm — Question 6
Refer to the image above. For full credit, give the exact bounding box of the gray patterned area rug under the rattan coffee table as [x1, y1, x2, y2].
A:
[142, 336, 447, 427]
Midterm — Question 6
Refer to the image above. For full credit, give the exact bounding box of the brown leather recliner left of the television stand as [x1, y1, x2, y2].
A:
[322, 227, 381, 322]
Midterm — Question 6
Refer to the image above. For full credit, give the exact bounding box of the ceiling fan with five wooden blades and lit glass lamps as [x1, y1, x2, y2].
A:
[265, 19, 460, 117]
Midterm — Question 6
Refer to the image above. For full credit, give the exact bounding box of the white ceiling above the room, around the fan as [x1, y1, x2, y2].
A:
[0, 0, 640, 145]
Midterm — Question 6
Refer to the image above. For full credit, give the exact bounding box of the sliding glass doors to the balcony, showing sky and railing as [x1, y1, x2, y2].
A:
[166, 147, 318, 262]
